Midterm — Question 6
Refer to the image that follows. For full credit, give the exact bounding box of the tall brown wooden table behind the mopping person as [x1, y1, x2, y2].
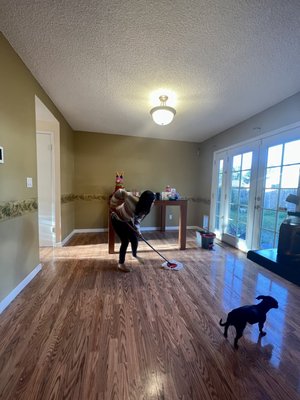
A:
[108, 200, 187, 254]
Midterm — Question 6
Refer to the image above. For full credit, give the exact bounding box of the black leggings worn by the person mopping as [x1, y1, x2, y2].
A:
[111, 216, 138, 264]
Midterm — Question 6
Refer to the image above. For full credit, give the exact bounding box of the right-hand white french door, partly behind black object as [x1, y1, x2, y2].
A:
[253, 130, 300, 249]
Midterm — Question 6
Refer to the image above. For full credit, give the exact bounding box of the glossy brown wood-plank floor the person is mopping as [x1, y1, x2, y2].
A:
[0, 231, 300, 400]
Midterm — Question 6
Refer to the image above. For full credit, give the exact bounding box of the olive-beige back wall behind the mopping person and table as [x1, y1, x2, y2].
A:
[75, 132, 203, 229]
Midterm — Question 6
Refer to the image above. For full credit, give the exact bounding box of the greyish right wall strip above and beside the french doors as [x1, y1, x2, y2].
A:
[199, 93, 300, 223]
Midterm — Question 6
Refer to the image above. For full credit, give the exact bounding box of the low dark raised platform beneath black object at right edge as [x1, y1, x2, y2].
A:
[247, 249, 300, 286]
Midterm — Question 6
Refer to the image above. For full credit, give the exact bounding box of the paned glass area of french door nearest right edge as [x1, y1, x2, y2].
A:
[259, 140, 300, 249]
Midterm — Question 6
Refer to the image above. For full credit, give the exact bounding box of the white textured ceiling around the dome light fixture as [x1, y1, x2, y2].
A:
[0, 0, 300, 142]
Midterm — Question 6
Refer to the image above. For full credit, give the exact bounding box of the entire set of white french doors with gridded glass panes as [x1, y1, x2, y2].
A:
[210, 128, 300, 251]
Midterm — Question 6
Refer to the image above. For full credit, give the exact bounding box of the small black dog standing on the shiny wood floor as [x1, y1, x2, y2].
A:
[220, 296, 278, 349]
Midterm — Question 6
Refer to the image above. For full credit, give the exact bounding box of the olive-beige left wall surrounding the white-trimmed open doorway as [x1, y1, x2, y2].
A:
[0, 33, 74, 301]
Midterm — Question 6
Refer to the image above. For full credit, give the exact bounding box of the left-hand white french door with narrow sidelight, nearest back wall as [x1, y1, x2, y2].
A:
[212, 144, 258, 249]
